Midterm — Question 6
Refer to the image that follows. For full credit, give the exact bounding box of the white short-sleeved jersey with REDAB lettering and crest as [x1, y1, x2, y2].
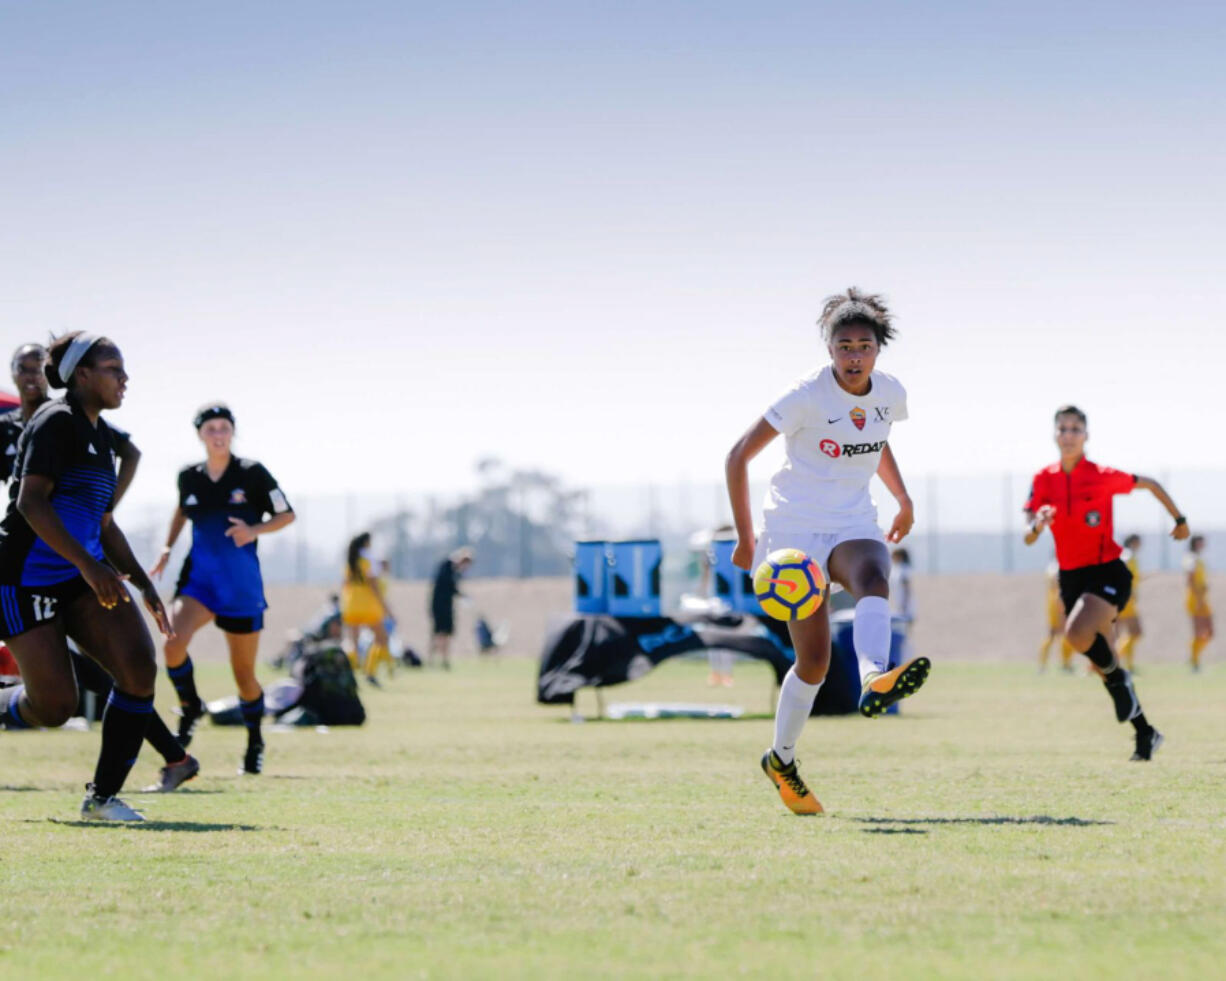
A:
[764, 364, 907, 533]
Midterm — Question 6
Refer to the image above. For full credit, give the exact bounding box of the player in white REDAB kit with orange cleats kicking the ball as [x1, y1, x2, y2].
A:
[725, 288, 931, 814]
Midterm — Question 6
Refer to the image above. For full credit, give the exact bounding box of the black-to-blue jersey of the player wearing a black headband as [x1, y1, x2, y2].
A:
[179, 456, 293, 613]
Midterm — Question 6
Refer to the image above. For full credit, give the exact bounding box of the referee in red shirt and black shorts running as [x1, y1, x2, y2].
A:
[1025, 406, 1188, 760]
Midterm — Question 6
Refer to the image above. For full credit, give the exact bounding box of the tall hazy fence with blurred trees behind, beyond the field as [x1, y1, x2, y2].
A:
[121, 471, 1226, 582]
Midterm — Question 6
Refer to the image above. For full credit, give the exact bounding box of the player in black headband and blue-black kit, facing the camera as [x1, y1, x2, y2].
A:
[152, 402, 294, 774]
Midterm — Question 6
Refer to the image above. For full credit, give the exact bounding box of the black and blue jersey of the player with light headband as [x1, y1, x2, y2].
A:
[0, 395, 115, 586]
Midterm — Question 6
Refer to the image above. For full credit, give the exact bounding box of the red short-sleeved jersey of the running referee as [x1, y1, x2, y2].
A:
[1025, 456, 1137, 569]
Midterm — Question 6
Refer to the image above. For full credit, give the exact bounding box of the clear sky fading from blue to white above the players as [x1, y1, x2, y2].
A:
[0, 1, 1226, 519]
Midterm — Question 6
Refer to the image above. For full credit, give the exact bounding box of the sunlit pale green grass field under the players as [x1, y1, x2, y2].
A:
[0, 661, 1226, 979]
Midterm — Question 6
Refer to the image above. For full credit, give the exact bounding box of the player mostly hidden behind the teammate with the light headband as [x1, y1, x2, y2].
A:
[0, 343, 200, 792]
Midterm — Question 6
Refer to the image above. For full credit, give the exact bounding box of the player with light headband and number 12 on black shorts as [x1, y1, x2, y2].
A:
[0, 331, 170, 822]
